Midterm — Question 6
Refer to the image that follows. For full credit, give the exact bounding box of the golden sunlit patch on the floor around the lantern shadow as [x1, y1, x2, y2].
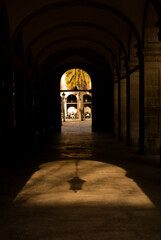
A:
[14, 160, 154, 208]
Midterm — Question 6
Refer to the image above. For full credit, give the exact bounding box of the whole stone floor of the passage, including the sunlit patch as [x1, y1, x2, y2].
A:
[0, 122, 161, 240]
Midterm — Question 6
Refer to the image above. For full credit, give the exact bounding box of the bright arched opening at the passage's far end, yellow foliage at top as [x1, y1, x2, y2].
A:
[60, 68, 92, 132]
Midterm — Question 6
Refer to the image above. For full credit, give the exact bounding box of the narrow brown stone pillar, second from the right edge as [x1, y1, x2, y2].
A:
[128, 30, 141, 151]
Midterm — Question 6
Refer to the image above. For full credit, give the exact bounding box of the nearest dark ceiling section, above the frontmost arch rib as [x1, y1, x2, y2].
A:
[6, 0, 146, 36]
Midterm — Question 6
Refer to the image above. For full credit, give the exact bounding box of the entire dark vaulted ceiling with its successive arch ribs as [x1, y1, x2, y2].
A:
[6, 0, 157, 74]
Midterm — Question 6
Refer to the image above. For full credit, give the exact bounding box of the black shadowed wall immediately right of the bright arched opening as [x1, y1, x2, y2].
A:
[92, 68, 114, 134]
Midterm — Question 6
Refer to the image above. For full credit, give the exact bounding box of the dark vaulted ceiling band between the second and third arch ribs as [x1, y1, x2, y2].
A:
[30, 24, 120, 57]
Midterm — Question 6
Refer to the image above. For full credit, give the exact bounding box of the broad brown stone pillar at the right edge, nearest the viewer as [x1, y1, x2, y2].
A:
[144, 49, 161, 154]
